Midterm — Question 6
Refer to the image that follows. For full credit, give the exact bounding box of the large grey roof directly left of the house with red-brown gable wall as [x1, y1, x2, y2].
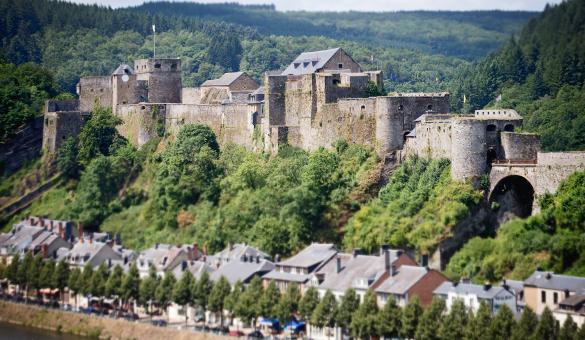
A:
[317, 250, 406, 292]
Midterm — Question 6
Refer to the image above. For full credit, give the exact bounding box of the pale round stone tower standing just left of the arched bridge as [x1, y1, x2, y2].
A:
[451, 118, 487, 181]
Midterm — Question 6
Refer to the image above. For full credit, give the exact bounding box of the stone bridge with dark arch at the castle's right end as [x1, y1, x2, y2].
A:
[489, 152, 585, 217]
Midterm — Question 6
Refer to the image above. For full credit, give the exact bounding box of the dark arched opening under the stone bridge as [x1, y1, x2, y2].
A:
[490, 175, 534, 223]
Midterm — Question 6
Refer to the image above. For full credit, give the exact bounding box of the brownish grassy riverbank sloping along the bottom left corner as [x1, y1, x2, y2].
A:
[0, 301, 221, 340]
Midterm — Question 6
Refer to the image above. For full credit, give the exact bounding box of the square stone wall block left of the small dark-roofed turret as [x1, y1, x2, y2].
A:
[77, 76, 112, 112]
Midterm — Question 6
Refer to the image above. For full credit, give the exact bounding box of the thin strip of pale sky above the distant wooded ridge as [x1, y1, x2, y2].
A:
[69, 0, 562, 11]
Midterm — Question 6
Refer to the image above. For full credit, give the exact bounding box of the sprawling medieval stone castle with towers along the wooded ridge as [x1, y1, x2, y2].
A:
[43, 48, 585, 215]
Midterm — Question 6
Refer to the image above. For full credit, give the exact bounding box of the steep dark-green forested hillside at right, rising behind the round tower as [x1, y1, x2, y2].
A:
[451, 0, 585, 151]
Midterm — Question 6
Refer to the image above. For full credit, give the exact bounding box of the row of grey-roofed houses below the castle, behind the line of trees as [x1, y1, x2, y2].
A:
[0, 217, 585, 332]
